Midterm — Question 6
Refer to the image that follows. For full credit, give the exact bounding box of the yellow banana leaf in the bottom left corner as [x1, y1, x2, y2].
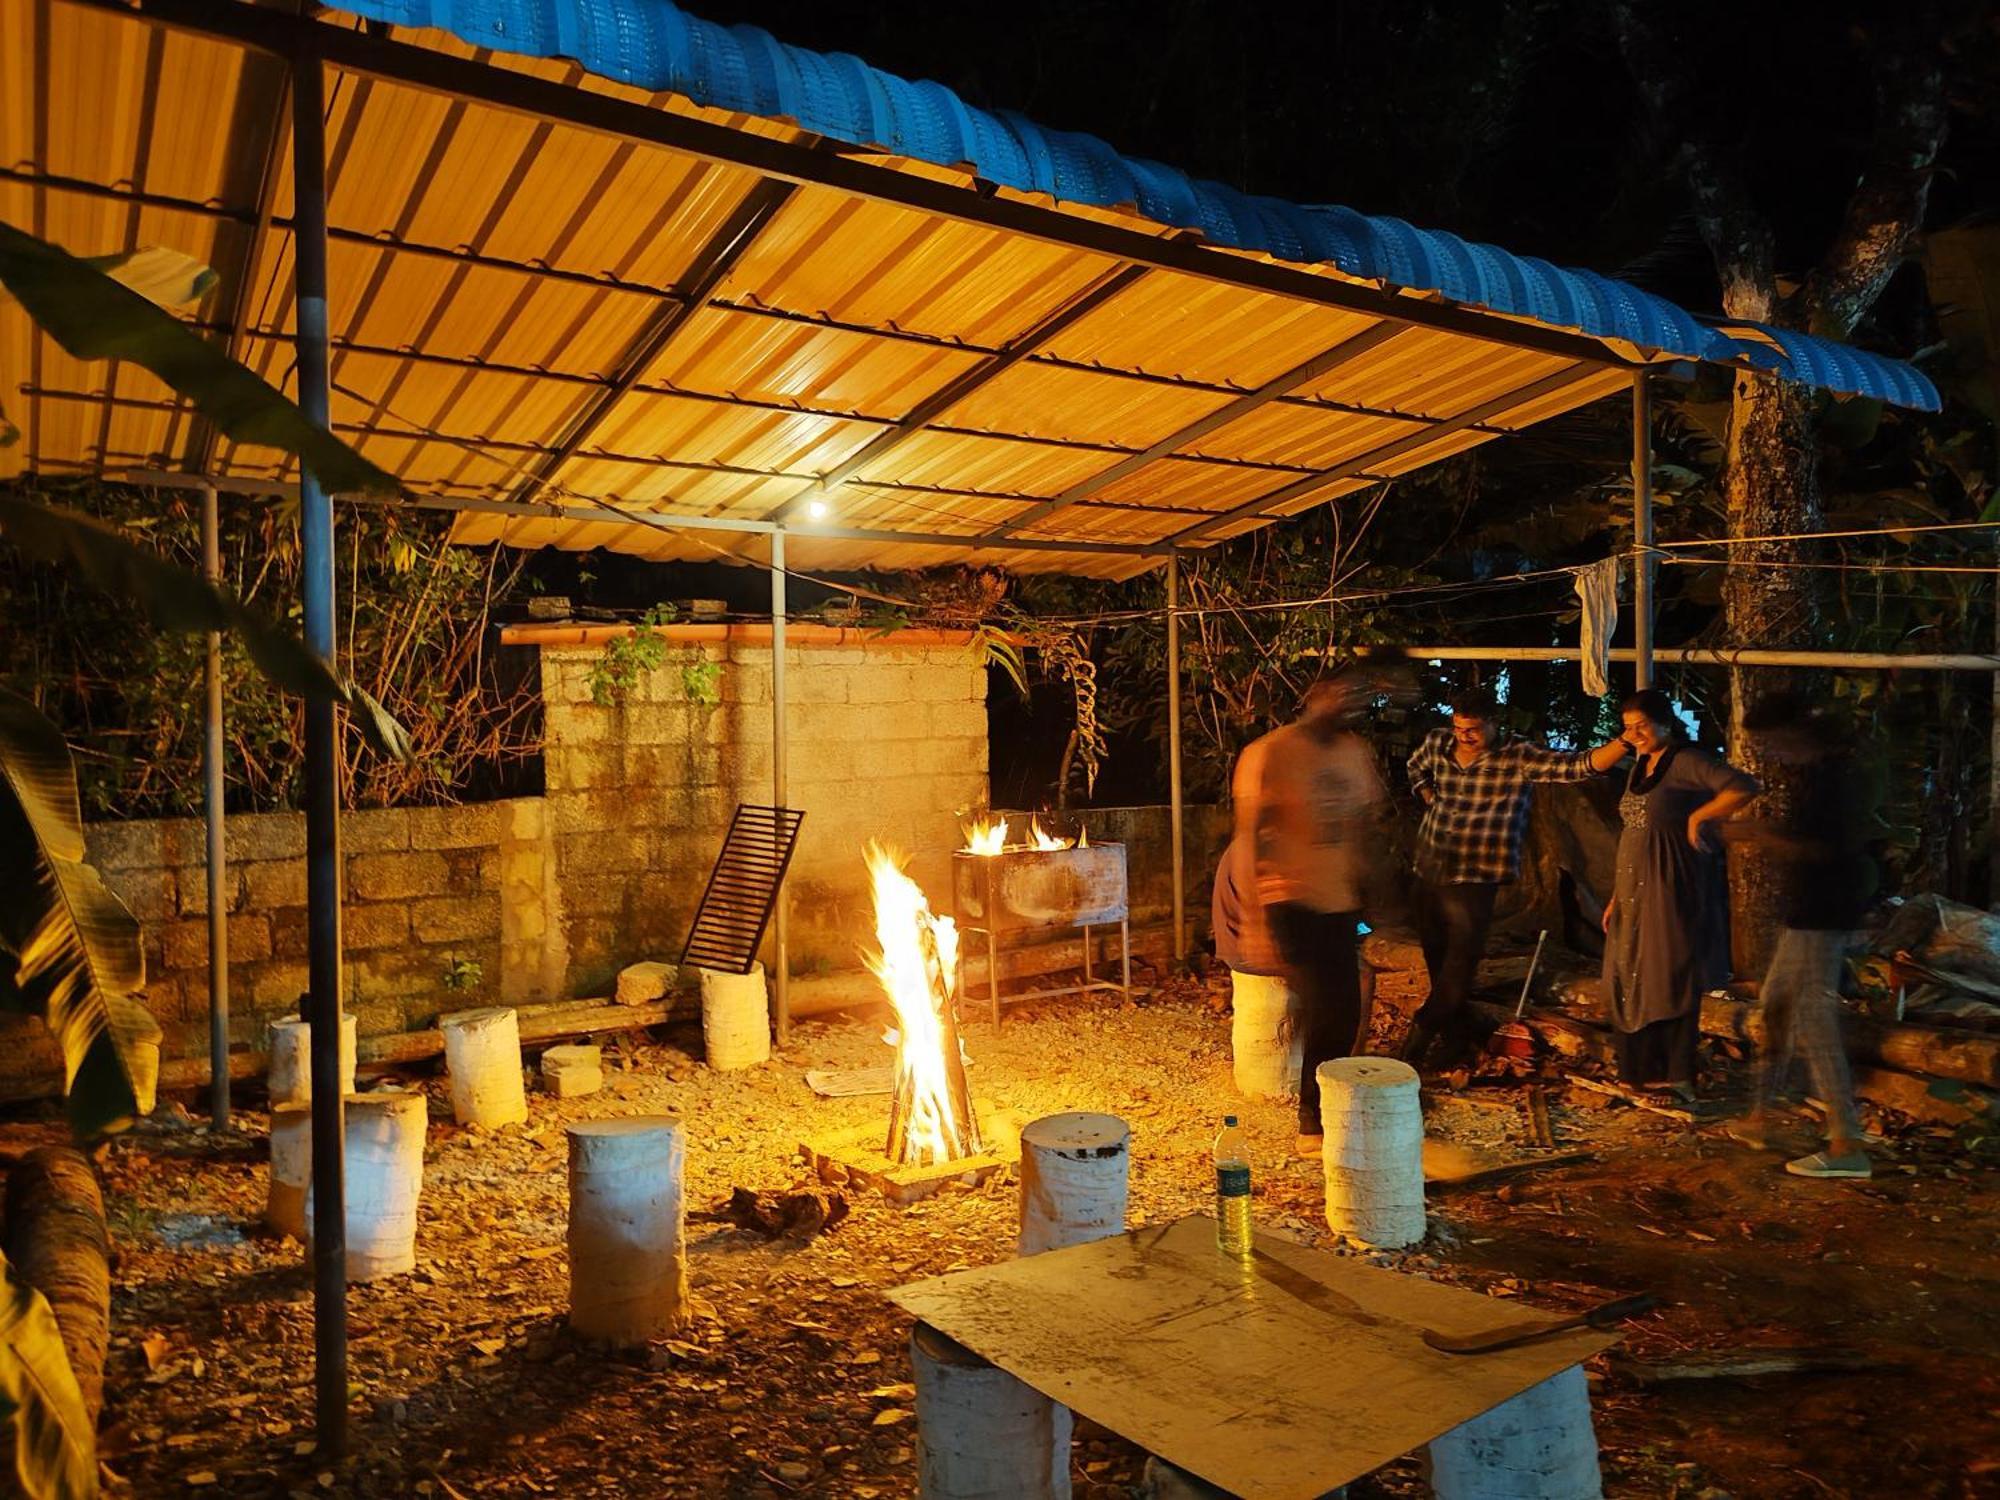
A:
[0, 1256, 98, 1500]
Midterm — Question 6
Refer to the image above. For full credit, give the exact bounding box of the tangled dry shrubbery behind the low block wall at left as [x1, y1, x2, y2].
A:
[0, 480, 524, 818]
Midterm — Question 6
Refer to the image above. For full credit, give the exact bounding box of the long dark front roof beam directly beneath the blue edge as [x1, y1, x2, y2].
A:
[82, 0, 1630, 366]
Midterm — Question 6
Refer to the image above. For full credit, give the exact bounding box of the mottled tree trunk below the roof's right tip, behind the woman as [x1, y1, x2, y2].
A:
[1722, 374, 1820, 978]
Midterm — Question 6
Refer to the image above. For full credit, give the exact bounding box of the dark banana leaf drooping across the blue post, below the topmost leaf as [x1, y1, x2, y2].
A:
[0, 492, 410, 760]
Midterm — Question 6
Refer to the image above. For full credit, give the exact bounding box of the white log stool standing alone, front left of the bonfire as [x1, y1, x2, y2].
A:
[570, 1114, 688, 1344]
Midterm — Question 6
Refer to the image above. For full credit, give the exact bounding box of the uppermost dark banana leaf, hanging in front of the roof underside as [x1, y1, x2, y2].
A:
[0, 220, 402, 494]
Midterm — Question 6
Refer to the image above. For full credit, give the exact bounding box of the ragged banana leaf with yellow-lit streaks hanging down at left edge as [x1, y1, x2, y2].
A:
[0, 688, 150, 1136]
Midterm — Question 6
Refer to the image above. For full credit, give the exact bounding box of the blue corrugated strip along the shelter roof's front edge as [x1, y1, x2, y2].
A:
[332, 0, 1938, 412]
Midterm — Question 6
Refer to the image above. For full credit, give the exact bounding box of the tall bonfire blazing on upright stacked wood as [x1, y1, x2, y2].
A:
[866, 840, 980, 1166]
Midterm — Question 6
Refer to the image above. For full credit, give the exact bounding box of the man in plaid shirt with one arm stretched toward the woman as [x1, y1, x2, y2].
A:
[1402, 692, 1626, 1064]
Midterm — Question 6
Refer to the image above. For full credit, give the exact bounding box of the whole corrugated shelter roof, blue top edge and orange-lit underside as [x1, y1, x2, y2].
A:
[0, 0, 1928, 576]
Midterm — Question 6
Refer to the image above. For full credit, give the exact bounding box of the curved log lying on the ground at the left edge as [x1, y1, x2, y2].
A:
[6, 1146, 112, 1424]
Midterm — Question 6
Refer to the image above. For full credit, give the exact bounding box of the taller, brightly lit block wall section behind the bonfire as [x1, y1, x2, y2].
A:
[540, 626, 986, 994]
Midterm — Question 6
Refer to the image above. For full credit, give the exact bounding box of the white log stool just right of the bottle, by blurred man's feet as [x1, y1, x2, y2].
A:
[1316, 1058, 1424, 1250]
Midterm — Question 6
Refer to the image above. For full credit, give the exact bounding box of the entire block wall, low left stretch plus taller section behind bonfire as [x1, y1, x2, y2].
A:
[0, 626, 1008, 1092]
